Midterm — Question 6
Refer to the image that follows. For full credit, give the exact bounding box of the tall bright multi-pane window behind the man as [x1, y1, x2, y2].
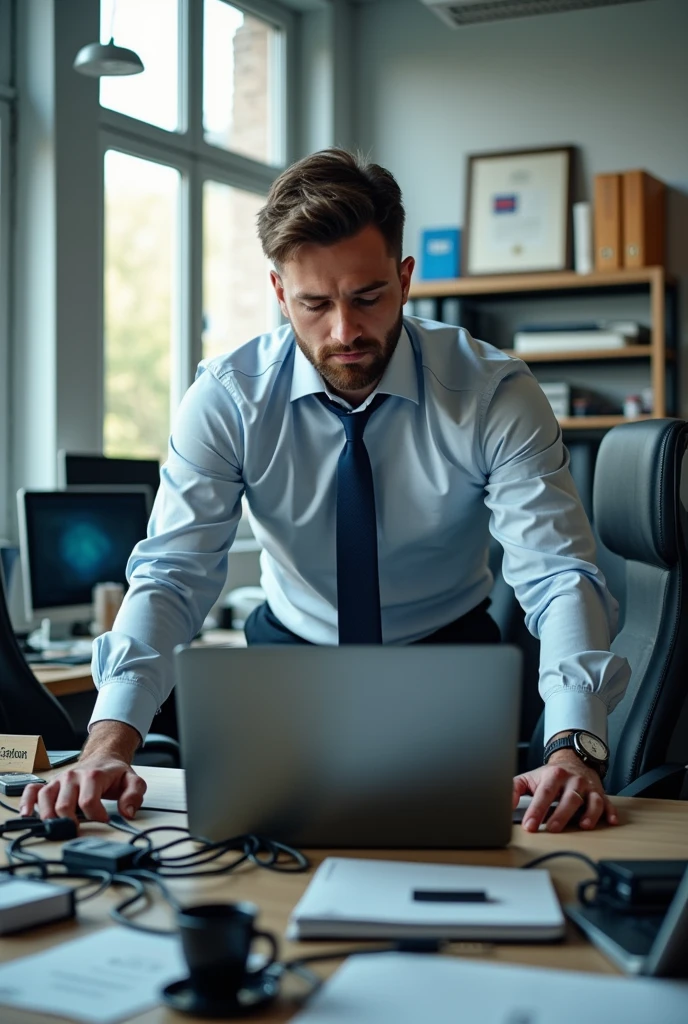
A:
[100, 0, 286, 458]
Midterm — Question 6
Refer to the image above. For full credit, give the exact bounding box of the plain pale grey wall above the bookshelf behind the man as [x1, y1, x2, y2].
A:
[351, 0, 688, 415]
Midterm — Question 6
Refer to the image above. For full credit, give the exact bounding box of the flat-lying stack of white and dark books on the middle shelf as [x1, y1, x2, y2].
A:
[514, 321, 650, 354]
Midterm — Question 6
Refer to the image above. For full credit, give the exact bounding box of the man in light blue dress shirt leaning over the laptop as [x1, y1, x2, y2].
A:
[23, 150, 629, 831]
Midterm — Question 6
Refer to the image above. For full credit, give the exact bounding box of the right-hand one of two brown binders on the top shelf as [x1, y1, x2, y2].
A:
[621, 171, 667, 266]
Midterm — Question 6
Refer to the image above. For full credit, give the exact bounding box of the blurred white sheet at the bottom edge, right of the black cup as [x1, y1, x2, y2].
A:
[293, 950, 688, 1024]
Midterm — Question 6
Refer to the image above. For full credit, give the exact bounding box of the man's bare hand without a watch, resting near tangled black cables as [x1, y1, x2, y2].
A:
[19, 721, 146, 821]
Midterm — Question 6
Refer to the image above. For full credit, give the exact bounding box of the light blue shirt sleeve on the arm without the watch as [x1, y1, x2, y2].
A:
[89, 369, 244, 737]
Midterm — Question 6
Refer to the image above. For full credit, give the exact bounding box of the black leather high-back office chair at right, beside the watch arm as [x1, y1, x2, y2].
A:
[530, 420, 688, 797]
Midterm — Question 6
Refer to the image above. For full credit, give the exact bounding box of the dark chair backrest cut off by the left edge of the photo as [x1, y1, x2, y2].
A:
[0, 557, 80, 750]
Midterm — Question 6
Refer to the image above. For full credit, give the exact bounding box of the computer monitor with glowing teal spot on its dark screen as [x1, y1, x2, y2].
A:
[16, 486, 149, 623]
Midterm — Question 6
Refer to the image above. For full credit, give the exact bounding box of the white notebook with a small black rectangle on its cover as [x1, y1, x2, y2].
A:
[287, 857, 564, 941]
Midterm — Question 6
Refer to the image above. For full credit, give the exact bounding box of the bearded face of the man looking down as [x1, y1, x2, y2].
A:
[270, 226, 414, 402]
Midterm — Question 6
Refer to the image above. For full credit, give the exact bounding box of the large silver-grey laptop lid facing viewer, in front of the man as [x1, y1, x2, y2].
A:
[175, 645, 521, 848]
